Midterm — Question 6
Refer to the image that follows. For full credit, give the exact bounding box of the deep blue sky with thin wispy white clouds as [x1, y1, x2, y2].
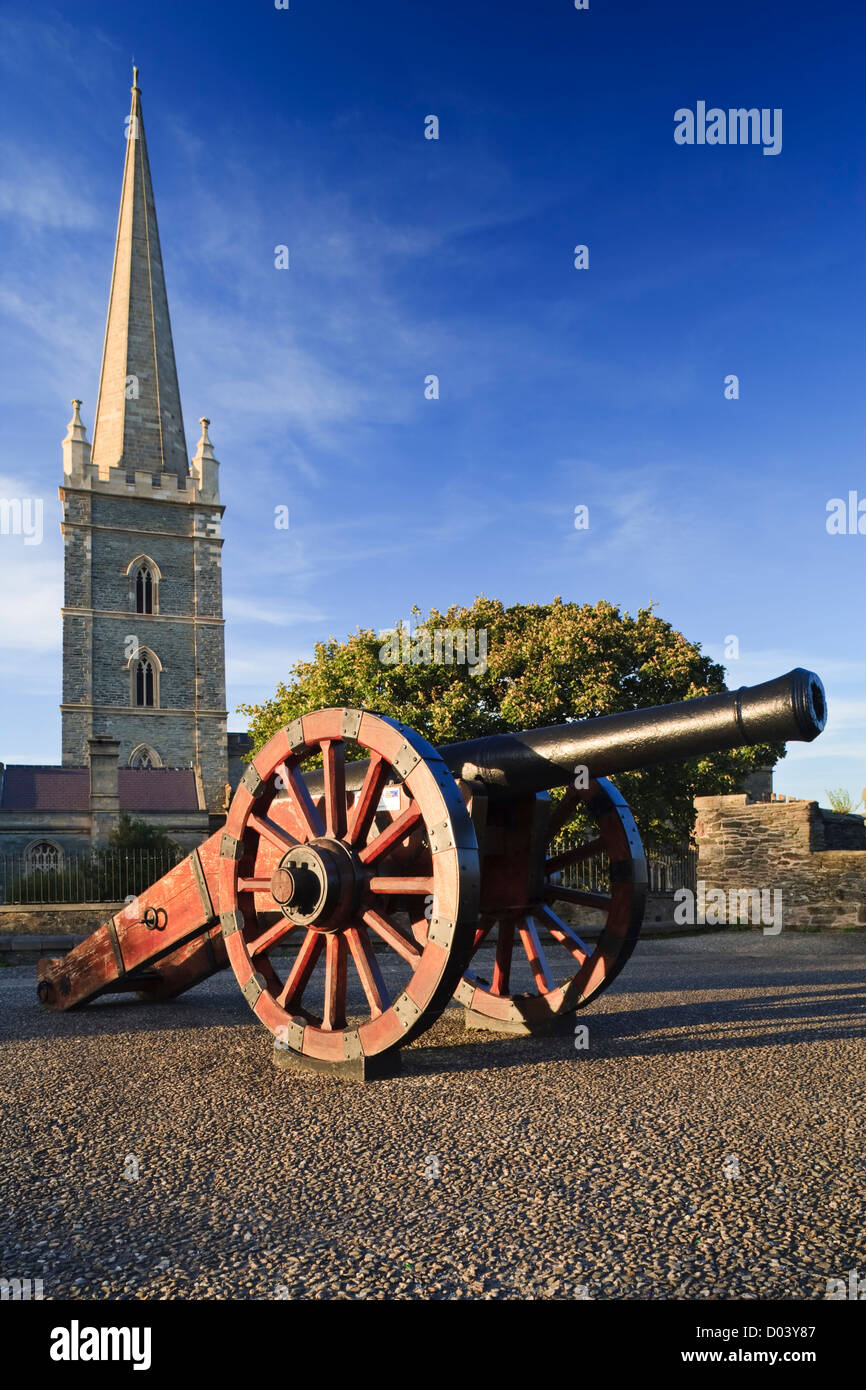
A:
[0, 0, 866, 799]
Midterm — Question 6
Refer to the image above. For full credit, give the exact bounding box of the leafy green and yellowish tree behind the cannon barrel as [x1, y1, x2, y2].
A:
[240, 595, 784, 845]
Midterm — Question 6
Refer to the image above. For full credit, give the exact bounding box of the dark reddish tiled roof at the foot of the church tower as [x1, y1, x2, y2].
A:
[0, 763, 199, 815]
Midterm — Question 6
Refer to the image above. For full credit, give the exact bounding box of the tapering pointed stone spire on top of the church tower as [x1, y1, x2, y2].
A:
[92, 68, 189, 485]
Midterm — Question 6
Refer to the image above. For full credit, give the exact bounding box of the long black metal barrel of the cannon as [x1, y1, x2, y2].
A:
[306, 666, 827, 799]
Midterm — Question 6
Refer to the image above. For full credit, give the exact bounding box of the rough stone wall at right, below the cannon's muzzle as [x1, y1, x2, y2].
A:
[695, 795, 866, 931]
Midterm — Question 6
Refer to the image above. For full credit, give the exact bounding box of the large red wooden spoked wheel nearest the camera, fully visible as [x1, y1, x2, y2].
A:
[220, 709, 478, 1069]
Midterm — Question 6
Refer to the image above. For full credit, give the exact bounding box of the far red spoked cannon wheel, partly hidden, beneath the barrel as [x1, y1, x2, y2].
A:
[456, 777, 646, 1033]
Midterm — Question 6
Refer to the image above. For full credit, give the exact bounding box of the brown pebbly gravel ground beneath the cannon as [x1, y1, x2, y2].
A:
[0, 933, 866, 1300]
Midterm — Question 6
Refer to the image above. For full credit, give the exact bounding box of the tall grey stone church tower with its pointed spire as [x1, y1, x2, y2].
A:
[60, 68, 227, 812]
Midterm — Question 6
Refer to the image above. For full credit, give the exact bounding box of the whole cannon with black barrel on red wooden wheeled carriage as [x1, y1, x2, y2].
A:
[38, 667, 827, 1080]
